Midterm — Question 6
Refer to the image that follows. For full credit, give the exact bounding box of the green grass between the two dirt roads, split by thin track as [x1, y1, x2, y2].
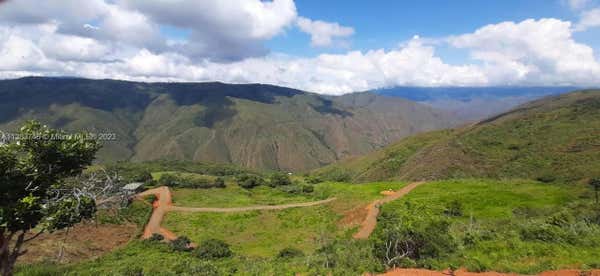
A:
[163, 182, 405, 257]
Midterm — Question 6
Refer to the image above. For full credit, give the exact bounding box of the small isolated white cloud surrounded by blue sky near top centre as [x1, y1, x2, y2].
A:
[297, 17, 354, 47]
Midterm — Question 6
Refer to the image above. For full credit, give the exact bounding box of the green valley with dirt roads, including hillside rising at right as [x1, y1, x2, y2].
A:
[4, 87, 600, 275]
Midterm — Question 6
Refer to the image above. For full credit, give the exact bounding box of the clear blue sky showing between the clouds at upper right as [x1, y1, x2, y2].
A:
[267, 0, 600, 59]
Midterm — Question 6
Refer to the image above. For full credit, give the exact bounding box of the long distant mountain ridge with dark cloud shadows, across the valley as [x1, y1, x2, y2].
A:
[0, 77, 454, 171]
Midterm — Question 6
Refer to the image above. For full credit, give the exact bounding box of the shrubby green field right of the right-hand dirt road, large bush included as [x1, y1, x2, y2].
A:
[373, 180, 600, 274]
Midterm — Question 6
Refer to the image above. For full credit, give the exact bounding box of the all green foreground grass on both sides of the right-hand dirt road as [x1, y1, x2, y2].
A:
[18, 179, 600, 275]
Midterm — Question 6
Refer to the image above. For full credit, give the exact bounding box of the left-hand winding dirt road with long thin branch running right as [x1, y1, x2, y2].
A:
[137, 186, 336, 240]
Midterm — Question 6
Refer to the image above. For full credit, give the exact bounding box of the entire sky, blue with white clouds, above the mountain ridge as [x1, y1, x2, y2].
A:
[0, 0, 600, 94]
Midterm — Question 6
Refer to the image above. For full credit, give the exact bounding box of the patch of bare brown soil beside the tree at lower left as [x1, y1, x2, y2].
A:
[19, 223, 137, 263]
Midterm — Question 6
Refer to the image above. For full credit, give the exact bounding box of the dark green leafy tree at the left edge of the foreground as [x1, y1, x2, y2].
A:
[0, 121, 100, 276]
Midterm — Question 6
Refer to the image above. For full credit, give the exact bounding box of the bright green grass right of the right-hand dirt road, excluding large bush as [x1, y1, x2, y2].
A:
[377, 180, 600, 273]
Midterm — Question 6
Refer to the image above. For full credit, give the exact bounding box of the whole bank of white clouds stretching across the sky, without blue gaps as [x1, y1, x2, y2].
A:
[0, 0, 600, 94]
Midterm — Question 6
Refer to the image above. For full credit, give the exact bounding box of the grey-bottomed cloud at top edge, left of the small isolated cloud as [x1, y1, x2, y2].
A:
[121, 0, 297, 61]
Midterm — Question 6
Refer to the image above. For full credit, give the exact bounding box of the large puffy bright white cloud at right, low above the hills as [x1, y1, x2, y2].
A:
[449, 19, 600, 85]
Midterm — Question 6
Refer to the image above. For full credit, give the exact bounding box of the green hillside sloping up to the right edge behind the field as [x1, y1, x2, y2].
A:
[315, 90, 600, 182]
